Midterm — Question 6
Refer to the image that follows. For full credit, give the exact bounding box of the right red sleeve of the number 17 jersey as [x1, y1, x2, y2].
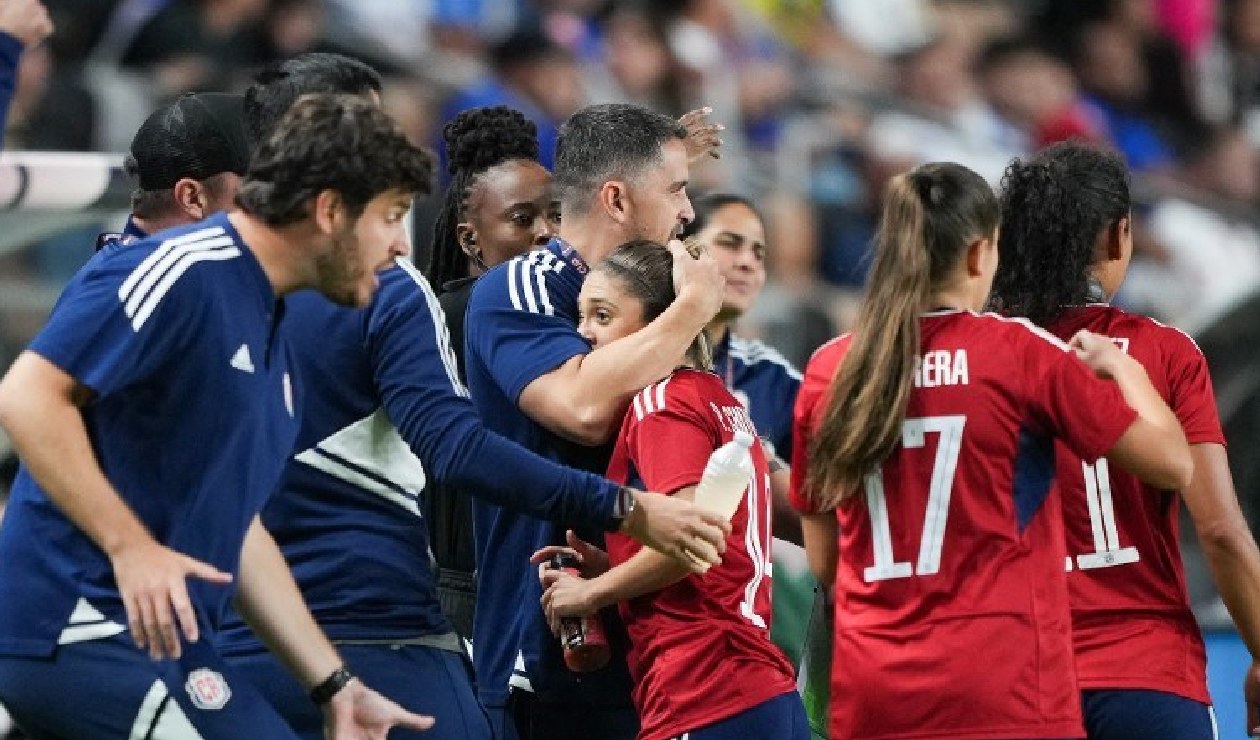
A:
[1024, 327, 1138, 460]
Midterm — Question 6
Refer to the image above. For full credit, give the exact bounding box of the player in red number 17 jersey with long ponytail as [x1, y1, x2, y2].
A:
[793, 164, 1192, 740]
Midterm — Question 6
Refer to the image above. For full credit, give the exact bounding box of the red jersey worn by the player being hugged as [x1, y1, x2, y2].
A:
[607, 369, 796, 740]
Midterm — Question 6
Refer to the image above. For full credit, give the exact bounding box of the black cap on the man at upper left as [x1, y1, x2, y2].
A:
[127, 92, 249, 190]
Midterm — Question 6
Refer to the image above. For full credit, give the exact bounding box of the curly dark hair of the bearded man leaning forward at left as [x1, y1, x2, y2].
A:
[236, 93, 433, 227]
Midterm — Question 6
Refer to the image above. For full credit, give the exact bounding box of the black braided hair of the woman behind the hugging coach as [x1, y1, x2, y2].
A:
[426, 106, 538, 291]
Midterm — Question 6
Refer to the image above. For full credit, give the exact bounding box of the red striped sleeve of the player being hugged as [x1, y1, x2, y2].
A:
[626, 379, 722, 494]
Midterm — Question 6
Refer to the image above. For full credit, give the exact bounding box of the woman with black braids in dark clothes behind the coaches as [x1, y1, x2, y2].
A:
[425, 106, 559, 638]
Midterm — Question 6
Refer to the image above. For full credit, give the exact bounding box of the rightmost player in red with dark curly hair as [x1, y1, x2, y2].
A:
[993, 142, 1260, 740]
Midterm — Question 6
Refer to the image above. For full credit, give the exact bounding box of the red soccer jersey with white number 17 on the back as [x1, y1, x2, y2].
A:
[791, 311, 1135, 740]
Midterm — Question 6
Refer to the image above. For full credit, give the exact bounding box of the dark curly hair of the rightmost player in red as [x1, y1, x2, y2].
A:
[989, 141, 1129, 325]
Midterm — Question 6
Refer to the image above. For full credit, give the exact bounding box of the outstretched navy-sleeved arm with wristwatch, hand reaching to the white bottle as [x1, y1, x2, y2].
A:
[367, 266, 730, 570]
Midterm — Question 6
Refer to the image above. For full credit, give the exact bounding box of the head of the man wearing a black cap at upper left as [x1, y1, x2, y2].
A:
[97, 92, 249, 247]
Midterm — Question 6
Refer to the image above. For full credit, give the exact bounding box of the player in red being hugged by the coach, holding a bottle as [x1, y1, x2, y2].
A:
[536, 241, 809, 740]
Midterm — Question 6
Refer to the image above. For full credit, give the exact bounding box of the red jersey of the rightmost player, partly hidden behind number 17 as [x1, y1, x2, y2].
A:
[1050, 305, 1225, 703]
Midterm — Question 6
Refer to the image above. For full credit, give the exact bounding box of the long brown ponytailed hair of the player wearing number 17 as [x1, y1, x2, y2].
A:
[806, 163, 999, 511]
